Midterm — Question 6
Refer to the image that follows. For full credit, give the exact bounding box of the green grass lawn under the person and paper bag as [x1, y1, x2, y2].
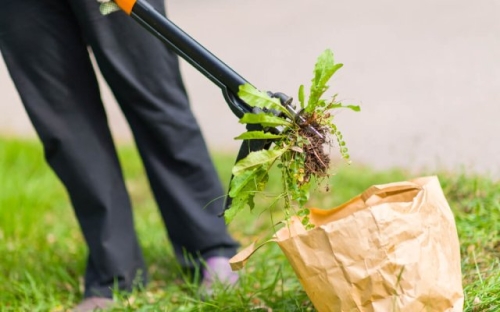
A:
[0, 138, 500, 311]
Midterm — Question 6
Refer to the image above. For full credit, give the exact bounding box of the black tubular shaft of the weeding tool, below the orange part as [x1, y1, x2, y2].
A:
[130, 0, 252, 118]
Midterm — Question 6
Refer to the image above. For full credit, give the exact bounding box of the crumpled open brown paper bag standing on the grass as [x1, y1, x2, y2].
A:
[230, 177, 463, 312]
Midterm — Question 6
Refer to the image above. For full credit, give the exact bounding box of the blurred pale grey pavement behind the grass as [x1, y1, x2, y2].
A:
[0, 0, 500, 177]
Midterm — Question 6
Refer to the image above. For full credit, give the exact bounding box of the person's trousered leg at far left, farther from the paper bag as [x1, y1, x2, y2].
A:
[0, 0, 146, 297]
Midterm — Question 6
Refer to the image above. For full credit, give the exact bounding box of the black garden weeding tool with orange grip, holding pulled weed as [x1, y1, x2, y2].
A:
[107, 0, 322, 212]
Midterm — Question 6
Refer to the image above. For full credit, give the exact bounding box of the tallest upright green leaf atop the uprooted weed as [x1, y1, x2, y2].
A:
[306, 49, 342, 112]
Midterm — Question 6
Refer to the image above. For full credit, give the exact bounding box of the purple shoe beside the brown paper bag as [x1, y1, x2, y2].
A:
[200, 257, 239, 296]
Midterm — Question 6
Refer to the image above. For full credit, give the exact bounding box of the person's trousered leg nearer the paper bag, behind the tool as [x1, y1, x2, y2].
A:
[72, 0, 237, 265]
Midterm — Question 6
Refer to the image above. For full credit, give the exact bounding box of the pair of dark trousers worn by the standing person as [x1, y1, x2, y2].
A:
[0, 0, 237, 296]
